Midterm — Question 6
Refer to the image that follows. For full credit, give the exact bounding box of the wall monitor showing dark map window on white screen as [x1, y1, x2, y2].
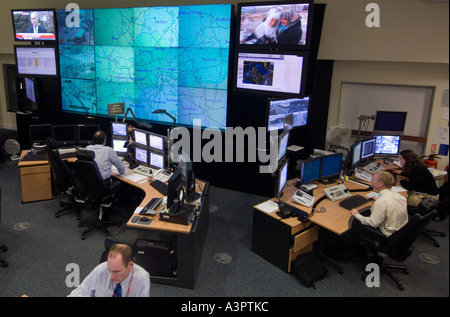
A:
[234, 51, 308, 97]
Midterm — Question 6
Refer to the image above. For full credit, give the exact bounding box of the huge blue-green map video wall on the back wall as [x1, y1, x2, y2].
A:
[58, 5, 231, 129]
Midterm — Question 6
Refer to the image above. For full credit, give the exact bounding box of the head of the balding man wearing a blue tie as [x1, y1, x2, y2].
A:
[107, 243, 134, 284]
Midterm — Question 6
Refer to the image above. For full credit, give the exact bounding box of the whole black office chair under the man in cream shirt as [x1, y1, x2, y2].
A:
[356, 210, 437, 290]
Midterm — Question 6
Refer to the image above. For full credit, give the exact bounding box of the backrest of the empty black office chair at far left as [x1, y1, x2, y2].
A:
[45, 145, 73, 193]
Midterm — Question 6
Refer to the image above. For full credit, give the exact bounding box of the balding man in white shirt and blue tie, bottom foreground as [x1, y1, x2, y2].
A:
[68, 243, 150, 297]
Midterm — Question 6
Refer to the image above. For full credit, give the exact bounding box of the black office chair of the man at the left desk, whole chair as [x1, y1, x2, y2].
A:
[74, 150, 121, 240]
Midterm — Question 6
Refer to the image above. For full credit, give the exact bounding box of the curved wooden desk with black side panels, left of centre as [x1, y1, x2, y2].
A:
[111, 174, 209, 288]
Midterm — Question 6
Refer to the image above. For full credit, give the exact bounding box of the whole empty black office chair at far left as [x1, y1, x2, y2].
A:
[45, 139, 80, 220]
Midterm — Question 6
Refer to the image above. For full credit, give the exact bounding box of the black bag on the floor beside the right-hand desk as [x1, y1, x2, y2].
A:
[291, 253, 328, 289]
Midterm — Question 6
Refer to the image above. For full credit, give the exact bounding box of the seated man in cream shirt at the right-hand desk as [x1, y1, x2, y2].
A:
[350, 171, 408, 240]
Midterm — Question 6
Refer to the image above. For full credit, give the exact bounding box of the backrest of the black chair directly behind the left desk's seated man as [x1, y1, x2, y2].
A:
[74, 150, 108, 202]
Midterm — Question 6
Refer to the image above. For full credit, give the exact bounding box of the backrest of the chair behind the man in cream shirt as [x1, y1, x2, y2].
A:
[388, 210, 437, 262]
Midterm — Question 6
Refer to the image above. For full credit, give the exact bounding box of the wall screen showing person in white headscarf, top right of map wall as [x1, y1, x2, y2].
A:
[237, 1, 313, 51]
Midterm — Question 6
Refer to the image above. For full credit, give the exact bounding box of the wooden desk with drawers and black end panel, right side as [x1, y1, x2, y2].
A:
[252, 161, 407, 272]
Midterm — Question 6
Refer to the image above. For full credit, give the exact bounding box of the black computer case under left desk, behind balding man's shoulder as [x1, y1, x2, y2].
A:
[134, 239, 177, 277]
